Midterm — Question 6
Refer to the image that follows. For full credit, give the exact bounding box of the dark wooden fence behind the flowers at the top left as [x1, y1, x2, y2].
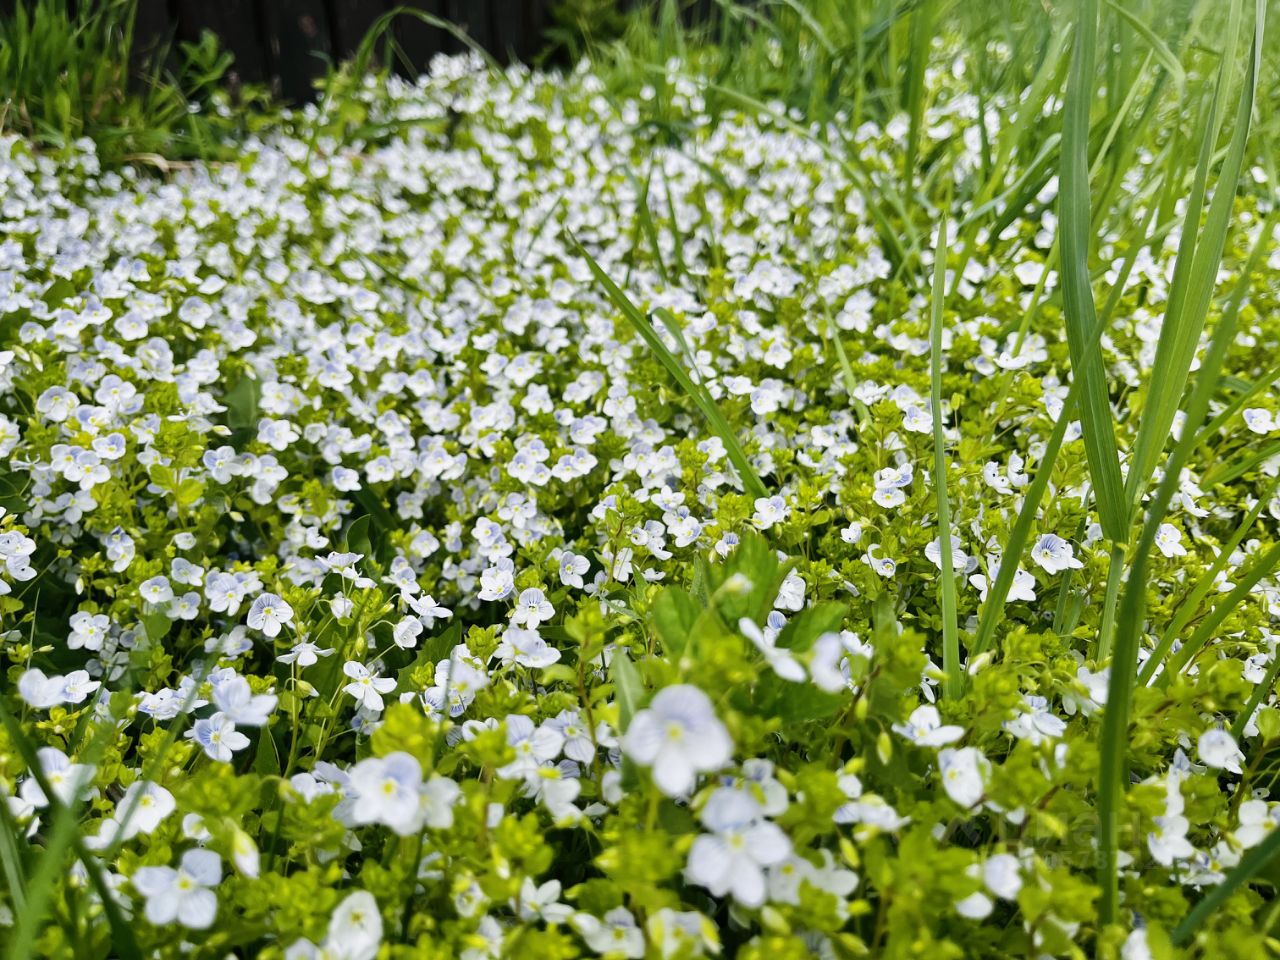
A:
[120, 0, 552, 102]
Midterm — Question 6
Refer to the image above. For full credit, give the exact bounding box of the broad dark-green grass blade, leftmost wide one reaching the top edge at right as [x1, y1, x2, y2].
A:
[1059, 0, 1129, 543]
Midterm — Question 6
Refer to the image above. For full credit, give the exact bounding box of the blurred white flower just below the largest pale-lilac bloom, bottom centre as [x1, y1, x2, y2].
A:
[685, 787, 791, 908]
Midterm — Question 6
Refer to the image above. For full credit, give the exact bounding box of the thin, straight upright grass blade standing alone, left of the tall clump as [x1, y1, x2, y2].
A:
[929, 216, 964, 698]
